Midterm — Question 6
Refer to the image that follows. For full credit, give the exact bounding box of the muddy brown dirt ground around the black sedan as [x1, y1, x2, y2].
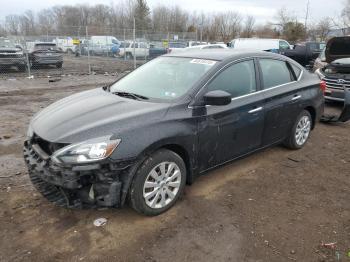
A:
[0, 75, 350, 262]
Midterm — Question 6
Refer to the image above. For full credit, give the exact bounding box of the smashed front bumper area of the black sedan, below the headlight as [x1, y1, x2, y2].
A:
[23, 141, 135, 207]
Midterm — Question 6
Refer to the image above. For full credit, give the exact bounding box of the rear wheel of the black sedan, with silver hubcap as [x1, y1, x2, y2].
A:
[284, 110, 312, 150]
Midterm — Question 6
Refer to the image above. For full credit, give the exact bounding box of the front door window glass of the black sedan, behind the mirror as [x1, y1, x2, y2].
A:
[208, 60, 256, 98]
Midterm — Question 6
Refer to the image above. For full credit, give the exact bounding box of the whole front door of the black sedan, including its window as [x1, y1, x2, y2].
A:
[199, 60, 264, 171]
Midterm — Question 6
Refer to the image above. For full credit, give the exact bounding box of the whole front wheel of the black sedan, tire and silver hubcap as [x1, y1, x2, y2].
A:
[129, 149, 186, 216]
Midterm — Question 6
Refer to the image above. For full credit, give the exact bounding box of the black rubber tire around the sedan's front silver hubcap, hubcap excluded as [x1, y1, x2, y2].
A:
[128, 149, 186, 216]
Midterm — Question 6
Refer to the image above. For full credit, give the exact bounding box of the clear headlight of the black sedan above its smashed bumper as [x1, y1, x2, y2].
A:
[52, 137, 121, 164]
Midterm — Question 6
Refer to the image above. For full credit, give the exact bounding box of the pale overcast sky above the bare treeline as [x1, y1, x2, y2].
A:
[0, 0, 346, 23]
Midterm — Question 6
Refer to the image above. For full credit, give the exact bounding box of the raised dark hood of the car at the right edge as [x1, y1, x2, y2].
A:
[326, 36, 350, 63]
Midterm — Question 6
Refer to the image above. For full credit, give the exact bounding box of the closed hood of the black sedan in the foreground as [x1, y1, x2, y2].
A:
[30, 88, 169, 143]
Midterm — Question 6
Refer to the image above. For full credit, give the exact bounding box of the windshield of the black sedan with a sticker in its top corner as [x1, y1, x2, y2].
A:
[110, 57, 216, 100]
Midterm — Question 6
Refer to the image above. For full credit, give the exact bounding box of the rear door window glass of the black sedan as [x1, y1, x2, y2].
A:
[259, 59, 294, 89]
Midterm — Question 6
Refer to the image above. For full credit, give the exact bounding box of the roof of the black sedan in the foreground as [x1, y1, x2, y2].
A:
[164, 48, 283, 61]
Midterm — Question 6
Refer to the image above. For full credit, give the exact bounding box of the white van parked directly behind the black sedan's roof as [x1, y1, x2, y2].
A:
[228, 38, 291, 53]
